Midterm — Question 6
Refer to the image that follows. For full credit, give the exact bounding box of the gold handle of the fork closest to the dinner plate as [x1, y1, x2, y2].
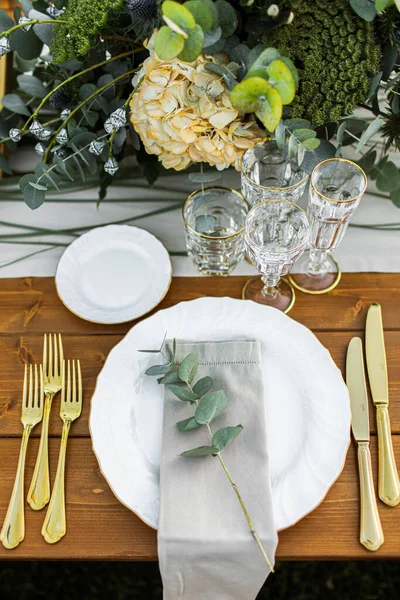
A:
[42, 419, 72, 544]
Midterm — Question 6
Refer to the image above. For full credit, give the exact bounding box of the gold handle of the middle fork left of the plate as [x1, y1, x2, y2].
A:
[27, 394, 54, 510]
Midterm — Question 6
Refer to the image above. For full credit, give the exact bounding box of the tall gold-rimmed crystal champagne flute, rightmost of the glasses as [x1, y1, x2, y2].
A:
[290, 158, 367, 294]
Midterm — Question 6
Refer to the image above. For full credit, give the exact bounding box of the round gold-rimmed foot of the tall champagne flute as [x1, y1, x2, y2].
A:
[289, 250, 342, 294]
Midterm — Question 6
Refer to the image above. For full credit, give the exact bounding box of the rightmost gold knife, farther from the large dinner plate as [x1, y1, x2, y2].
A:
[365, 303, 400, 506]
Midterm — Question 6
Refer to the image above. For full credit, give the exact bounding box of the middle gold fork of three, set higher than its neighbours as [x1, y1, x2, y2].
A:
[28, 333, 64, 510]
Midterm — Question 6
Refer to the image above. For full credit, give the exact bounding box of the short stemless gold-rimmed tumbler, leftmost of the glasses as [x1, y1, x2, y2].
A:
[182, 187, 250, 275]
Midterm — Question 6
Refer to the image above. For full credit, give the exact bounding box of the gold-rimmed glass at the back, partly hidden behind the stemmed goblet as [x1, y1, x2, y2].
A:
[241, 140, 308, 206]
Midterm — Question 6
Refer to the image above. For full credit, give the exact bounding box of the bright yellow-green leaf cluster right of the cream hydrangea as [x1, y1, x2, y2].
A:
[231, 48, 296, 132]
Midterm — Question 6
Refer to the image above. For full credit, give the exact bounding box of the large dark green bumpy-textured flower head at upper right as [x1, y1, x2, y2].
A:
[263, 0, 380, 125]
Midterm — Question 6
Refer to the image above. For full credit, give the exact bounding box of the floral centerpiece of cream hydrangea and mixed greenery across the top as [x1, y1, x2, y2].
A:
[0, 0, 400, 209]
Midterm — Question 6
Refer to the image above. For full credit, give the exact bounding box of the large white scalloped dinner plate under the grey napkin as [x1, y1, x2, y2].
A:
[90, 298, 350, 529]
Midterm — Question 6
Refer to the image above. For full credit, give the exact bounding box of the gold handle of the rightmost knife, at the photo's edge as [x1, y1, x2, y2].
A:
[376, 404, 400, 506]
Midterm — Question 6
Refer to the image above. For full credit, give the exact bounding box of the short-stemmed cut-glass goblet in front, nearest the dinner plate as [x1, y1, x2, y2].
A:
[242, 199, 310, 312]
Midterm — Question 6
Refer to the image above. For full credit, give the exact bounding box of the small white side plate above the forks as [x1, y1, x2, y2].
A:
[56, 225, 172, 323]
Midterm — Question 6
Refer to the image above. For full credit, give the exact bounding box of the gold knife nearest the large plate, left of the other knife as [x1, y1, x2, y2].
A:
[346, 337, 383, 550]
